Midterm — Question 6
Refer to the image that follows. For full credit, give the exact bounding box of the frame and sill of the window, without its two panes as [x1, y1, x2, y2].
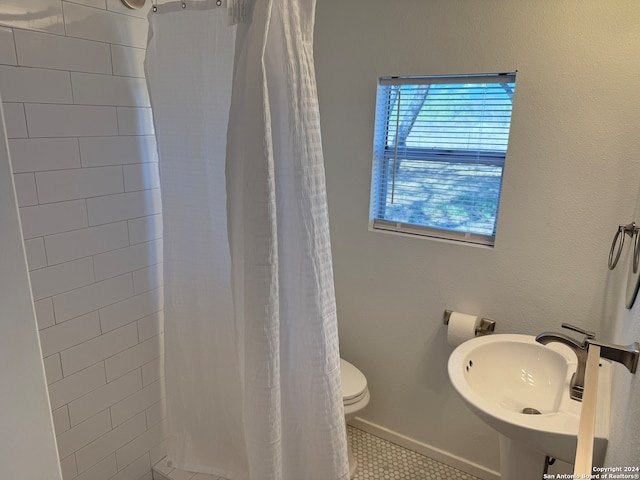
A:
[369, 72, 516, 247]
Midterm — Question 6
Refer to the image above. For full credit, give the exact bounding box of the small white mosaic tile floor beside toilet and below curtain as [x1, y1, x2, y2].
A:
[153, 426, 478, 480]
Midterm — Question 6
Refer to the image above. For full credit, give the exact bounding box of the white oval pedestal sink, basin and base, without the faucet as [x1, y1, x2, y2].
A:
[448, 334, 612, 480]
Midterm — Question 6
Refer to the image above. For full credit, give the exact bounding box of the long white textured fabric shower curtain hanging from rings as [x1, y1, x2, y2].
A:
[145, 0, 348, 480]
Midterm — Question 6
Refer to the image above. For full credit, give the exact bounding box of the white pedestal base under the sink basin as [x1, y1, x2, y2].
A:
[498, 433, 547, 480]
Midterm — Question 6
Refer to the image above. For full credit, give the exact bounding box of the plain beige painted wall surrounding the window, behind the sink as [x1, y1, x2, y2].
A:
[315, 0, 640, 471]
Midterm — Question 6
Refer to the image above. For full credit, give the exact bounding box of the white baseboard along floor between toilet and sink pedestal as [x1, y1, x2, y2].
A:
[349, 417, 500, 480]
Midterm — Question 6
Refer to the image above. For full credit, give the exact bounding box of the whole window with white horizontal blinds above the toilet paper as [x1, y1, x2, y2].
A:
[370, 73, 515, 246]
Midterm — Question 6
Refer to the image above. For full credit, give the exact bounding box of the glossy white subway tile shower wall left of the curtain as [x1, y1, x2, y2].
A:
[0, 0, 165, 480]
